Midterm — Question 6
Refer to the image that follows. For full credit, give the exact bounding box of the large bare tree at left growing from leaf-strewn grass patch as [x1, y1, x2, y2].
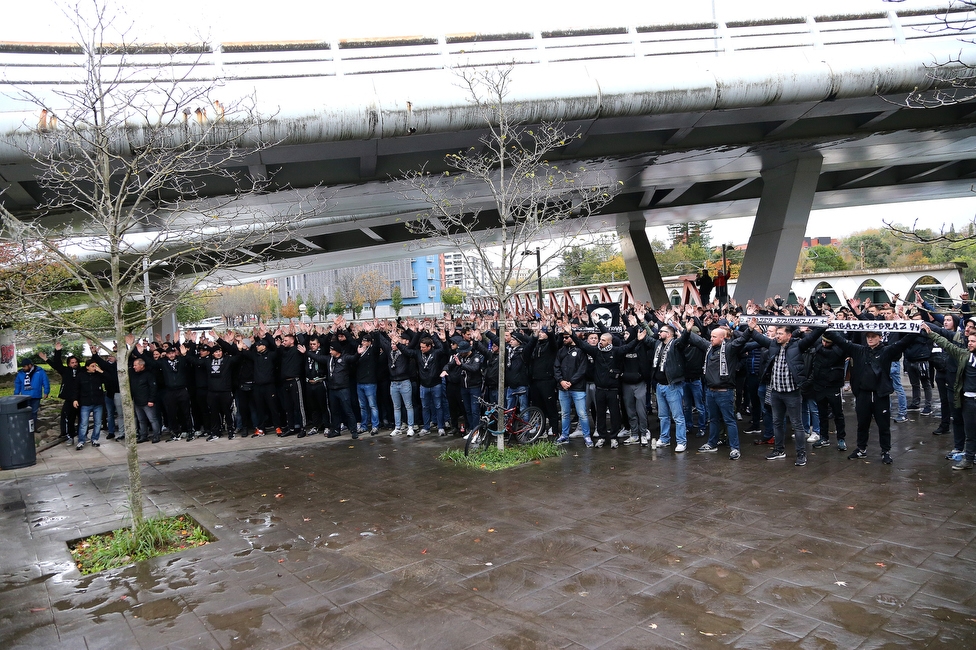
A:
[0, 0, 316, 527]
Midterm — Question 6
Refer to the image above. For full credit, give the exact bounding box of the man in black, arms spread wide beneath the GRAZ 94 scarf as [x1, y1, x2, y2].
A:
[827, 324, 919, 465]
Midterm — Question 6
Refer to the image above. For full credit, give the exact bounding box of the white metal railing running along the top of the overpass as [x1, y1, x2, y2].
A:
[0, 6, 976, 85]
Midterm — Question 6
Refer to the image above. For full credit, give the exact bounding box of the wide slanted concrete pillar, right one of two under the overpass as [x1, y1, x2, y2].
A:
[734, 154, 823, 305]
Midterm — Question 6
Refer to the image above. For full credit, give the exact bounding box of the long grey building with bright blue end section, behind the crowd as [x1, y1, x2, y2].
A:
[278, 255, 443, 318]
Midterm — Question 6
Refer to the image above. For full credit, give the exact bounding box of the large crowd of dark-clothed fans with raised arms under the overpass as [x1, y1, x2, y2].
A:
[17, 294, 976, 469]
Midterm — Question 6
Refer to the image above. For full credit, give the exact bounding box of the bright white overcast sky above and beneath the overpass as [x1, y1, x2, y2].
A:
[0, 0, 976, 244]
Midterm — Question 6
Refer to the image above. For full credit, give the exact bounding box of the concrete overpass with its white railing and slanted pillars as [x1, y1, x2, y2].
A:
[0, 0, 976, 302]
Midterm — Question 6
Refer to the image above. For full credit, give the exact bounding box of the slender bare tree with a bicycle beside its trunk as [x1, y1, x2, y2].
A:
[400, 66, 622, 449]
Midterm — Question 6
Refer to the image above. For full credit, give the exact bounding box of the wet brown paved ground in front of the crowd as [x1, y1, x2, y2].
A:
[0, 404, 976, 650]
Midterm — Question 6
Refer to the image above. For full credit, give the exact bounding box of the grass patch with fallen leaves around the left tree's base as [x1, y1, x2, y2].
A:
[68, 515, 214, 575]
